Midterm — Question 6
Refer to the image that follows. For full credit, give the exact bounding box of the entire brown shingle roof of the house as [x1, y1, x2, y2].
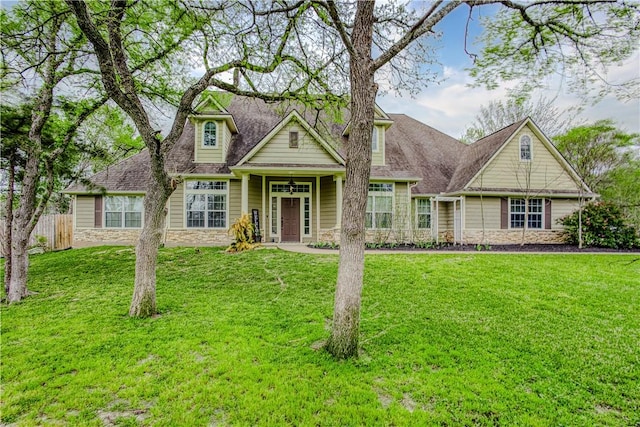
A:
[67, 96, 523, 194]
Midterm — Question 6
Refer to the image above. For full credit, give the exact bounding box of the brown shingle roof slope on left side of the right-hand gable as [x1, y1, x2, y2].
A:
[446, 118, 528, 192]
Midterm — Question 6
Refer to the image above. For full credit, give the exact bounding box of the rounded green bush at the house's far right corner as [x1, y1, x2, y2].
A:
[558, 202, 640, 249]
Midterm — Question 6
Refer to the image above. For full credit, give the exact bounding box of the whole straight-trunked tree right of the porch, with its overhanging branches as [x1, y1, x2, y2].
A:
[316, 0, 638, 358]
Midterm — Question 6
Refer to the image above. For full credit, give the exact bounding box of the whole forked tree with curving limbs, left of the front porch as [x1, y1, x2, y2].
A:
[67, 0, 344, 317]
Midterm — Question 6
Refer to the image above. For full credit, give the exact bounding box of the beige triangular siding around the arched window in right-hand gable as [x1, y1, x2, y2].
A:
[470, 127, 579, 191]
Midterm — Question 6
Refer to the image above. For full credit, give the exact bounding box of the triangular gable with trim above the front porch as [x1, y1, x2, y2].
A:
[236, 110, 344, 166]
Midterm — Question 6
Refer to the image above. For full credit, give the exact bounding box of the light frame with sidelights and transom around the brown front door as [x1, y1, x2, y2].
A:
[267, 180, 313, 243]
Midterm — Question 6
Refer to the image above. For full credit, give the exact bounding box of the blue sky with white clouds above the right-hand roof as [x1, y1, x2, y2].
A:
[377, 4, 640, 138]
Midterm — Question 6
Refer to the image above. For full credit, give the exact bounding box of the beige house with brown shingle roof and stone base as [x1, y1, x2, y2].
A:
[66, 93, 595, 245]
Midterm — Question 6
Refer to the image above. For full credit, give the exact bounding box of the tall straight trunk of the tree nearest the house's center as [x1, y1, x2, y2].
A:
[327, 2, 377, 359]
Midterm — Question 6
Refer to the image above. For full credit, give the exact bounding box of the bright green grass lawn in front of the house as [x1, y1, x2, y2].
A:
[0, 247, 640, 426]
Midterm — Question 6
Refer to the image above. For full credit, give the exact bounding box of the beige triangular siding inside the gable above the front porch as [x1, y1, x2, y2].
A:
[247, 122, 337, 165]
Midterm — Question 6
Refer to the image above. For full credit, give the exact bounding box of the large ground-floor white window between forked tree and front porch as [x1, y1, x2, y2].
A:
[185, 181, 229, 228]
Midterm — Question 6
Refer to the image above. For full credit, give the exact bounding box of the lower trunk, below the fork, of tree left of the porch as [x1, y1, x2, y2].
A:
[129, 155, 173, 317]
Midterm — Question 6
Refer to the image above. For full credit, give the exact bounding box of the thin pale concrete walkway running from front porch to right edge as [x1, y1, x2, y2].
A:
[276, 243, 640, 255]
